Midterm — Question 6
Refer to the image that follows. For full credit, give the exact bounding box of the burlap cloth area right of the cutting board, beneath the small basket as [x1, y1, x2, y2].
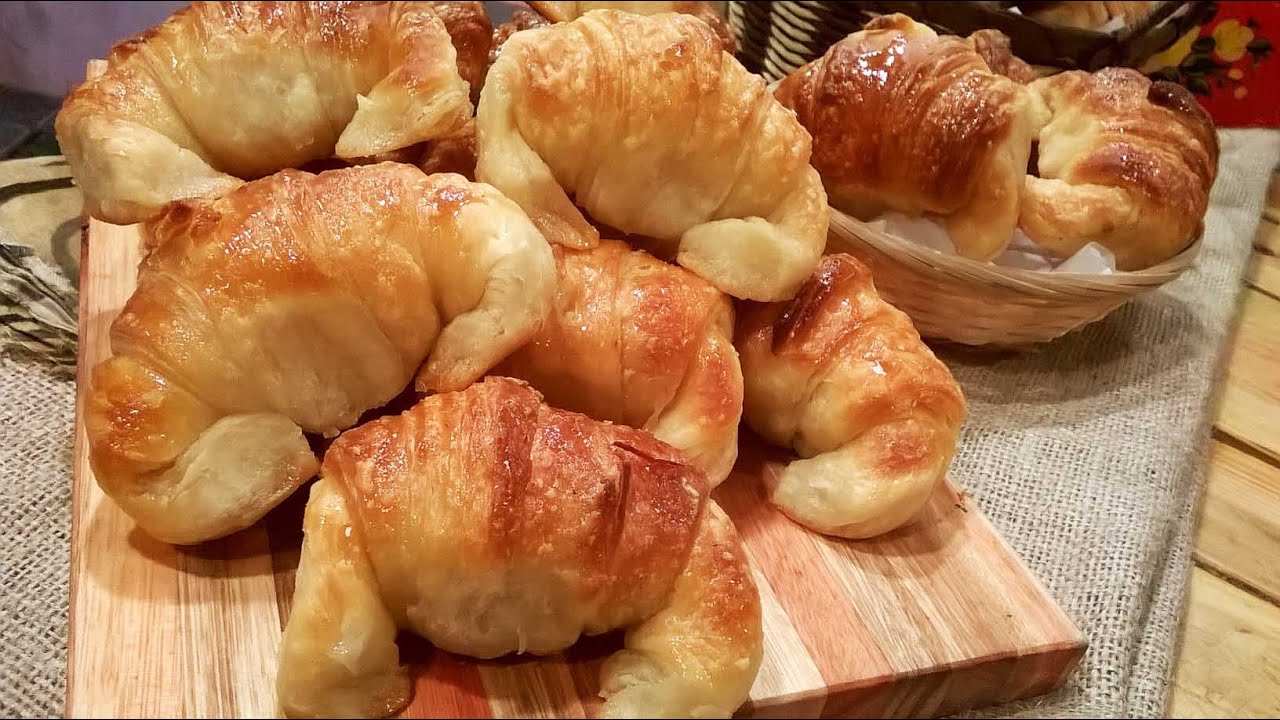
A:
[962, 131, 1280, 717]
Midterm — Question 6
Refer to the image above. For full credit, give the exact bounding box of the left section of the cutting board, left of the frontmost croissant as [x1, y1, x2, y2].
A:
[65, 61, 280, 717]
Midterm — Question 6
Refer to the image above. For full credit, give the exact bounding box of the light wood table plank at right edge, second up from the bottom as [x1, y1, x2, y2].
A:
[1196, 438, 1280, 602]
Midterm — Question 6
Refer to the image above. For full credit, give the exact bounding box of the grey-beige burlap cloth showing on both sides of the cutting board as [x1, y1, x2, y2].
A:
[0, 131, 1280, 716]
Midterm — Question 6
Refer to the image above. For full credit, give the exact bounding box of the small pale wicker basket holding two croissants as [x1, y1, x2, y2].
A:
[827, 209, 1201, 348]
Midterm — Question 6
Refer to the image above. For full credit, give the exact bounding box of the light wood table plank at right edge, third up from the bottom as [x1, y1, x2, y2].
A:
[1217, 290, 1280, 461]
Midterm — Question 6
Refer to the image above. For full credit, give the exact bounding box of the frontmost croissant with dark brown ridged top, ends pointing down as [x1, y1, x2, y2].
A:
[276, 377, 763, 717]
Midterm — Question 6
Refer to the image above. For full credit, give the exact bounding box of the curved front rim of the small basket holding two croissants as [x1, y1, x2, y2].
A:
[831, 208, 1203, 299]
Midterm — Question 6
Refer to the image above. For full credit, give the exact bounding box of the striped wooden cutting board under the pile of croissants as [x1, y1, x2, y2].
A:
[67, 212, 1084, 717]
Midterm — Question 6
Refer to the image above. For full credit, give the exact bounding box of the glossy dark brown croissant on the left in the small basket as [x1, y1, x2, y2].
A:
[777, 14, 1037, 260]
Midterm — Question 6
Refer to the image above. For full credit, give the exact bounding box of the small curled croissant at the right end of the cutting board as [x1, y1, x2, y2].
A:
[737, 255, 965, 538]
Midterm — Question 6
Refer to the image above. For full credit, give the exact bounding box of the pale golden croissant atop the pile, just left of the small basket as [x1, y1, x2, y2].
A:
[476, 10, 828, 300]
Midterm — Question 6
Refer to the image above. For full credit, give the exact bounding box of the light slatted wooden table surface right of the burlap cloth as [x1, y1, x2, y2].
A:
[1170, 170, 1280, 717]
